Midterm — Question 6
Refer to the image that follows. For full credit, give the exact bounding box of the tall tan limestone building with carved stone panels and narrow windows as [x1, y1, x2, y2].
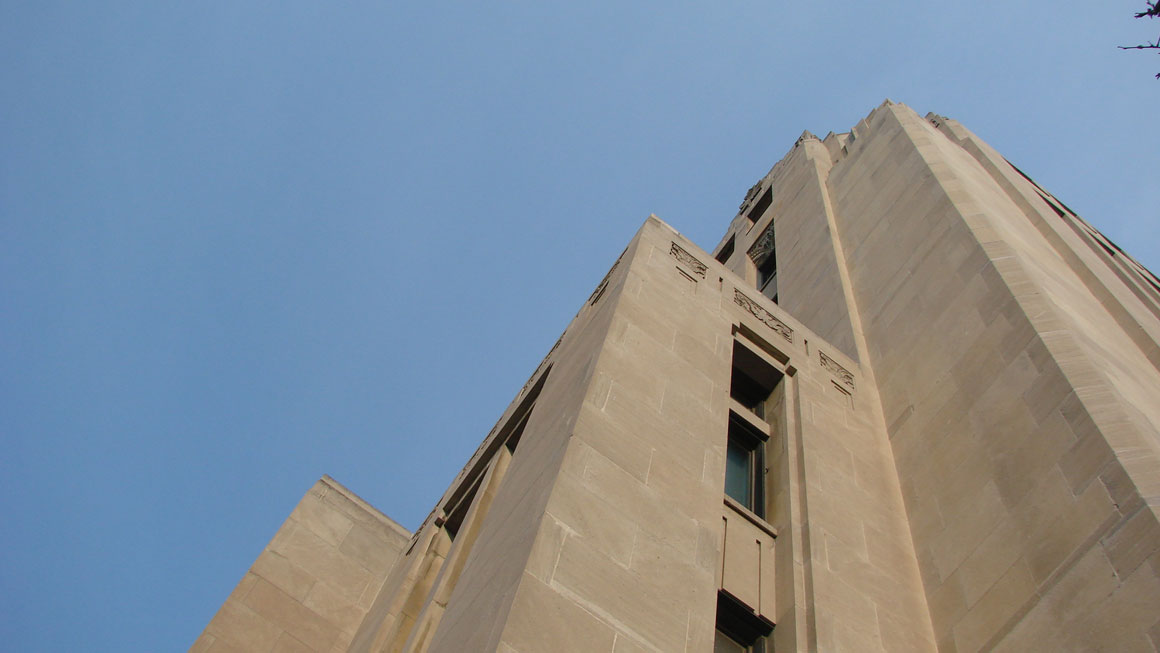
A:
[193, 101, 1160, 653]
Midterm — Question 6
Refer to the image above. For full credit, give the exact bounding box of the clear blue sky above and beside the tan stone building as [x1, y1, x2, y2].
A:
[0, 0, 1160, 652]
